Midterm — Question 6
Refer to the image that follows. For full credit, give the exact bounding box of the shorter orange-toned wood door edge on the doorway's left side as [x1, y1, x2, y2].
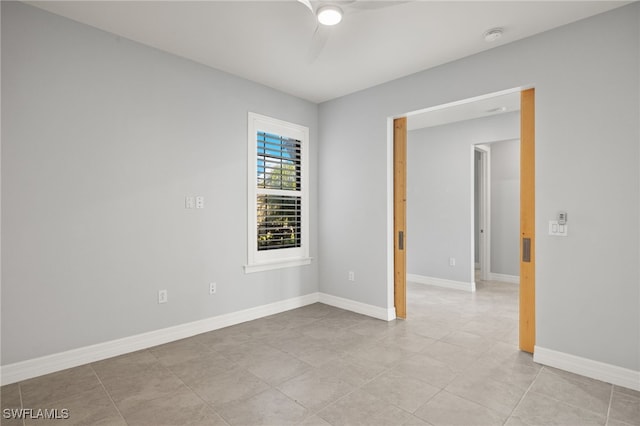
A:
[393, 117, 407, 319]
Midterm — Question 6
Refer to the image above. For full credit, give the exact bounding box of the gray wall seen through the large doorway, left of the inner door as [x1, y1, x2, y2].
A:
[407, 112, 520, 283]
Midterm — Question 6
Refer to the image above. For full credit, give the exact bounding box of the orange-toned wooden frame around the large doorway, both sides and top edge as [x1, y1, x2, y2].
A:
[387, 88, 536, 353]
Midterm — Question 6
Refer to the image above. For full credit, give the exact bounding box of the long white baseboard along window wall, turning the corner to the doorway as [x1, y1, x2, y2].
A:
[0, 293, 396, 385]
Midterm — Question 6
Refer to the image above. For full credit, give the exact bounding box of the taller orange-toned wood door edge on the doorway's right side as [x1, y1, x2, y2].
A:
[520, 89, 536, 353]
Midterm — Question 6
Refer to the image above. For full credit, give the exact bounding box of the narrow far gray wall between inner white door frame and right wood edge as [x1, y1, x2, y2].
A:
[490, 140, 520, 277]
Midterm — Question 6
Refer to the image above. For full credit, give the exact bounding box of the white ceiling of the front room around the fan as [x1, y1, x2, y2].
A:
[27, 0, 630, 102]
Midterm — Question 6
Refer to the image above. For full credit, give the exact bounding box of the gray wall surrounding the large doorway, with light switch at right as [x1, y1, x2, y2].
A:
[318, 3, 640, 371]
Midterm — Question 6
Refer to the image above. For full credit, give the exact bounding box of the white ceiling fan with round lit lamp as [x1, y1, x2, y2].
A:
[297, 0, 410, 62]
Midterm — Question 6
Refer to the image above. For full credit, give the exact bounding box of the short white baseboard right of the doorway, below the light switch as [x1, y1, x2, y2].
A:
[533, 346, 640, 391]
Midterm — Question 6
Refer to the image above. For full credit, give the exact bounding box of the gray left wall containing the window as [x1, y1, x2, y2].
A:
[1, 2, 318, 365]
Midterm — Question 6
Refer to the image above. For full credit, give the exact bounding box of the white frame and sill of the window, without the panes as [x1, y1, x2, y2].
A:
[244, 112, 311, 273]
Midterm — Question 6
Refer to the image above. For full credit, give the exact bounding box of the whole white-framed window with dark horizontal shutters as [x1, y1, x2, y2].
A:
[245, 113, 311, 272]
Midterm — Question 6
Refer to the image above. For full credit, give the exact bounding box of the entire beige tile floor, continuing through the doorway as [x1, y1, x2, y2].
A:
[2, 282, 640, 426]
